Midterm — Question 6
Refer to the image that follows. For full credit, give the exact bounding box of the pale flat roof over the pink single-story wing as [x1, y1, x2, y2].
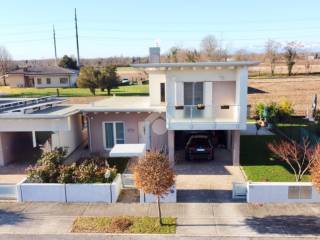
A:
[81, 96, 166, 112]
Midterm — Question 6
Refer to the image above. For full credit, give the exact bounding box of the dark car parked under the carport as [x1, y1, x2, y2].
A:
[185, 134, 214, 160]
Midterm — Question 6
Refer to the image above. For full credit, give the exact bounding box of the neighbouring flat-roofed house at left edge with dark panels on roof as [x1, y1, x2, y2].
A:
[0, 97, 86, 166]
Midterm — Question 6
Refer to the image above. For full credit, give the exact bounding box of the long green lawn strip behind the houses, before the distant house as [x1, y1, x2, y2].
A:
[0, 85, 149, 97]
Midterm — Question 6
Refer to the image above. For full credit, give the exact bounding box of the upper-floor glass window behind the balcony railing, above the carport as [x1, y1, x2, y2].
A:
[184, 82, 203, 105]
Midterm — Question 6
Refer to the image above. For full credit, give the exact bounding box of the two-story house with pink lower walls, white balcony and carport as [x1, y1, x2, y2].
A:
[82, 55, 258, 165]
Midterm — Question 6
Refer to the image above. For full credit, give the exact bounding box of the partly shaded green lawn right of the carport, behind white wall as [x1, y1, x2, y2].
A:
[240, 136, 310, 182]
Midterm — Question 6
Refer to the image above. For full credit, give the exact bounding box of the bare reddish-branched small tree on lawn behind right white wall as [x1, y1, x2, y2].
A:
[268, 138, 319, 182]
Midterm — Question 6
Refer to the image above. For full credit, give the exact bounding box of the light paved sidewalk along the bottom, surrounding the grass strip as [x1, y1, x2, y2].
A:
[0, 203, 320, 239]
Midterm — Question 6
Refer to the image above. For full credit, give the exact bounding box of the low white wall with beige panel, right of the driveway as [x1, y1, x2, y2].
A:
[247, 182, 320, 203]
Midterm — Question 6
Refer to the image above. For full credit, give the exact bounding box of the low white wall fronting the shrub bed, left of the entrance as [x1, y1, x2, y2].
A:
[17, 174, 122, 203]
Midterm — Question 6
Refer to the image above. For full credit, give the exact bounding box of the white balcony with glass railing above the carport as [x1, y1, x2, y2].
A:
[167, 105, 240, 130]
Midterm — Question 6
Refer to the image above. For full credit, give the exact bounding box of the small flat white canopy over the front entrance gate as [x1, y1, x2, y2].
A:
[109, 144, 146, 157]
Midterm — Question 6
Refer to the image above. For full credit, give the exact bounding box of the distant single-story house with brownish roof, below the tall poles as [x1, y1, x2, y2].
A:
[6, 66, 78, 88]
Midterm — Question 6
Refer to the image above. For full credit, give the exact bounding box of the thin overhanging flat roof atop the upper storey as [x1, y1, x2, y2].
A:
[131, 61, 260, 68]
